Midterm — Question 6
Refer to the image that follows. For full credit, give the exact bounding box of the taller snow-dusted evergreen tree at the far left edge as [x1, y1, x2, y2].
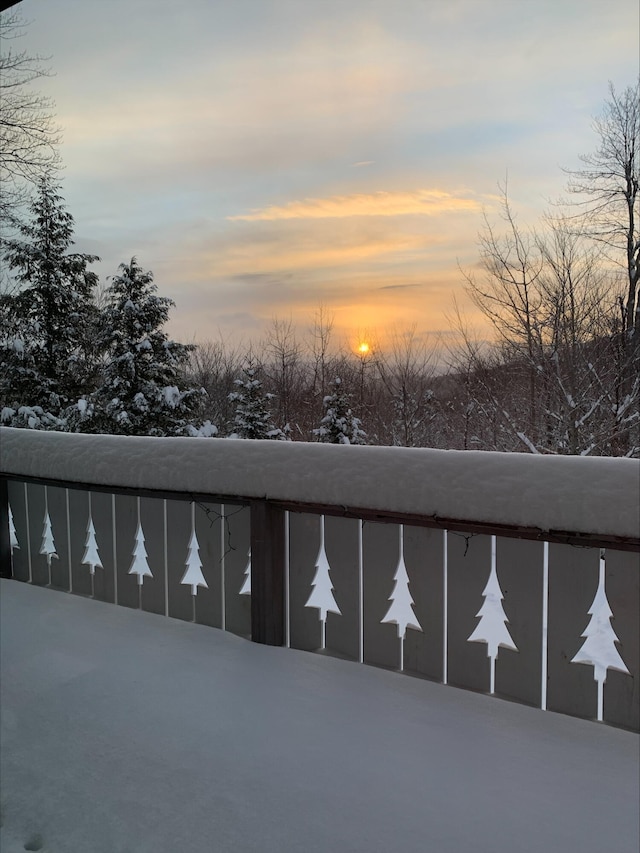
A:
[0, 179, 98, 429]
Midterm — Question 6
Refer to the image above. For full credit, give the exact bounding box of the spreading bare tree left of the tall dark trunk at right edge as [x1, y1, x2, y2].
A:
[465, 186, 639, 455]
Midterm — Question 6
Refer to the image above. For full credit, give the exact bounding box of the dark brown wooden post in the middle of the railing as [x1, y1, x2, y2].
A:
[251, 501, 285, 646]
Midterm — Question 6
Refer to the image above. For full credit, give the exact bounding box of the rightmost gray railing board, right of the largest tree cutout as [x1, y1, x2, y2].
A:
[604, 549, 640, 731]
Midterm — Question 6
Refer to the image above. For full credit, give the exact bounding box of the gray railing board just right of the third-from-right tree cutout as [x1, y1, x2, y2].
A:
[403, 525, 446, 681]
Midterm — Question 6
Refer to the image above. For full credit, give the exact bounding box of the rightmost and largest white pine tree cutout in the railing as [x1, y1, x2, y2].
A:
[571, 553, 630, 720]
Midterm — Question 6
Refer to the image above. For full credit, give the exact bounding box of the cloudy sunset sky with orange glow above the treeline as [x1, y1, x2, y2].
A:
[11, 0, 639, 350]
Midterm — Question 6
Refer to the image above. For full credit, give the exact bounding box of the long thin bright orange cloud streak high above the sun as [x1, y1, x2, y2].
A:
[227, 190, 482, 222]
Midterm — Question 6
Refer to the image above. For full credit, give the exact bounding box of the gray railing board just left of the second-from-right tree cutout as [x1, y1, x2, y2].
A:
[447, 533, 496, 691]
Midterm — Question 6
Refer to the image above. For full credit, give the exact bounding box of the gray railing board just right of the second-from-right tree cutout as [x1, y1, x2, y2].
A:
[495, 537, 544, 708]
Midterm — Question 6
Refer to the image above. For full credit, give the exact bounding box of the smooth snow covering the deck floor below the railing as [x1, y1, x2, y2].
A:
[0, 580, 640, 853]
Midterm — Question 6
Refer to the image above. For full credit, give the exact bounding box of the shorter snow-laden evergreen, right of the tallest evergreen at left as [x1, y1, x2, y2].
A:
[86, 258, 203, 436]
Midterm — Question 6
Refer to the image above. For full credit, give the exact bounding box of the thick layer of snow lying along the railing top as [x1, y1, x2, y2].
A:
[0, 427, 640, 539]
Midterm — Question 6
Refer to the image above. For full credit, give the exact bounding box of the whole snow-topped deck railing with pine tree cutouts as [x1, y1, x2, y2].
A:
[0, 429, 640, 729]
